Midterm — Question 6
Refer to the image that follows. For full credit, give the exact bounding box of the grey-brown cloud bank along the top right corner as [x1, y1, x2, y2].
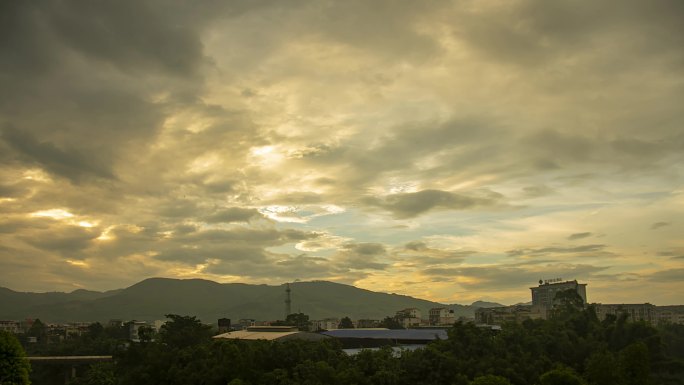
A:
[453, 0, 684, 66]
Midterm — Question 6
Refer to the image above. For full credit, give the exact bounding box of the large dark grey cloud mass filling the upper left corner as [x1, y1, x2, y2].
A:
[0, 1, 211, 186]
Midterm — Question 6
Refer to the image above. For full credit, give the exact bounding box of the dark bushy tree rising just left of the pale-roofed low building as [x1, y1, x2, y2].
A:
[159, 314, 211, 348]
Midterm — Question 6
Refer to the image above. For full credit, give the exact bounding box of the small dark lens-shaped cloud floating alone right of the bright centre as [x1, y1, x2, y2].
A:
[363, 190, 502, 219]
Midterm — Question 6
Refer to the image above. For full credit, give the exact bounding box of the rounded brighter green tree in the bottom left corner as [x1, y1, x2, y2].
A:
[0, 330, 31, 385]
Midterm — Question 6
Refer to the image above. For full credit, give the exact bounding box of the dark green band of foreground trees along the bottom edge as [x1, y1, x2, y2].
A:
[13, 307, 684, 385]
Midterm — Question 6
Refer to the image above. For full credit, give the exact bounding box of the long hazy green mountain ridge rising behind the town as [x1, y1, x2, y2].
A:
[0, 278, 484, 323]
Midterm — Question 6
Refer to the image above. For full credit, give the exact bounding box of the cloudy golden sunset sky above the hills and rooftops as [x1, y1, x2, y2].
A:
[0, 0, 684, 305]
